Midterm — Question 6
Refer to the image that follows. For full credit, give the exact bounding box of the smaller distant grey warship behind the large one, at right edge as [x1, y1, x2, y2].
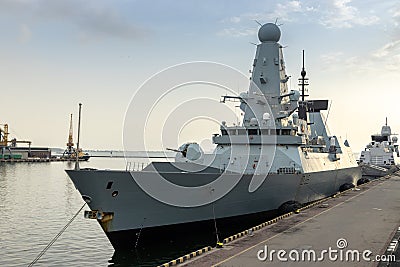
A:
[359, 118, 400, 178]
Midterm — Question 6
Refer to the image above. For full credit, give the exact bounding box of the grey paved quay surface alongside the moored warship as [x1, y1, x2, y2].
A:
[180, 174, 400, 267]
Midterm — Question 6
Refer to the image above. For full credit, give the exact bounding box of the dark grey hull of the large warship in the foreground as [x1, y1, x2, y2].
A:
[67, 163, 361, 247]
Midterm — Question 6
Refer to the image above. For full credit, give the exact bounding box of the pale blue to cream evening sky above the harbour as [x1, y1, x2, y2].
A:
[0, 0, 400, 151]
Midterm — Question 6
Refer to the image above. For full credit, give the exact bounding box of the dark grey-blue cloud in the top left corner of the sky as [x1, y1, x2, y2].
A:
[0, 0, 147, 40]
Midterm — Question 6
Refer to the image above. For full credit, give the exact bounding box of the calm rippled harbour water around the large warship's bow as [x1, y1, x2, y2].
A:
[0, 158, 212, 266]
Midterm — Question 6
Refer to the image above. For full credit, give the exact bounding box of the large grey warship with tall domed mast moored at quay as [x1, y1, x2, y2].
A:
[66, 23, 361, 248]
